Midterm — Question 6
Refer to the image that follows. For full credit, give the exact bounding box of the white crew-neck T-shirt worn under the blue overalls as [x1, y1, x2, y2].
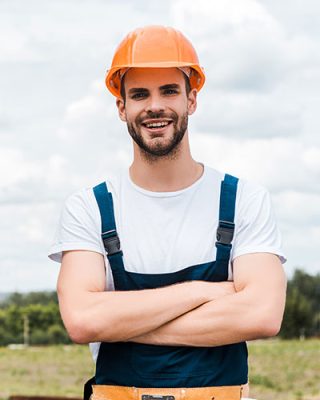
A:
[49, 166, 285, 358]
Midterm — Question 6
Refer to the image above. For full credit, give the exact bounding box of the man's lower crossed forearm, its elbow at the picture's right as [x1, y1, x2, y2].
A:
[132, 291, 284, 347]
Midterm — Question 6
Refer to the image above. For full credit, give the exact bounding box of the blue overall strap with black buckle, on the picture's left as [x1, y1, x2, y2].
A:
[93, 182, 123, 269]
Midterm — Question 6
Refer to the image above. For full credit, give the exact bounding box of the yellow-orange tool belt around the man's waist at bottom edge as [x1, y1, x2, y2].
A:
[91, 385, 246, 400]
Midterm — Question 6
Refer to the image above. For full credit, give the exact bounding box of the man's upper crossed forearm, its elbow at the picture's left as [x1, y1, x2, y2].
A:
[59, 282, 210, 343]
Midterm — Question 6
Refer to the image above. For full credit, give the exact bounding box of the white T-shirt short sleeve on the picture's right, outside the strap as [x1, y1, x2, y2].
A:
[232, 182, 286, 263]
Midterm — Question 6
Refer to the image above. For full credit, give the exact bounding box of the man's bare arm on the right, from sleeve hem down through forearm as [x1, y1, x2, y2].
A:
[132, 253, 286, 346]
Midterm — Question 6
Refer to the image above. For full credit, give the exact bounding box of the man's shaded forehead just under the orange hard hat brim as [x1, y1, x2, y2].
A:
[125, 68, 184, 89]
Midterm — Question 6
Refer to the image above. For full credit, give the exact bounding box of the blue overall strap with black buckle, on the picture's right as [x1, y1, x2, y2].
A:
[216, 174, 238, 271]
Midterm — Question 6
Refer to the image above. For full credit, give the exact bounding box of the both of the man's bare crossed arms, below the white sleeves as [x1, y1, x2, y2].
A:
[57, 250, 286, 346]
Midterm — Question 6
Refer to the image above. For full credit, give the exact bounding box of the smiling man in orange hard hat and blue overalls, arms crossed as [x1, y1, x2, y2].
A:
[50, 26, 286, 400]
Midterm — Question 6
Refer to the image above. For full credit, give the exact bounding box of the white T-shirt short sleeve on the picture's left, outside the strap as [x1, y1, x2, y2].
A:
[48, 189, 103, 262]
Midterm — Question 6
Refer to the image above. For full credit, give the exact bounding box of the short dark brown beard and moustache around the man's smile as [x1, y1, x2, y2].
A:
[127, 112, 188, 162]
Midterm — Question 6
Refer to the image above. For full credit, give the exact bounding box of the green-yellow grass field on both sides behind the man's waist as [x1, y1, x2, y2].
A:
[0, 340, 320, 400]
